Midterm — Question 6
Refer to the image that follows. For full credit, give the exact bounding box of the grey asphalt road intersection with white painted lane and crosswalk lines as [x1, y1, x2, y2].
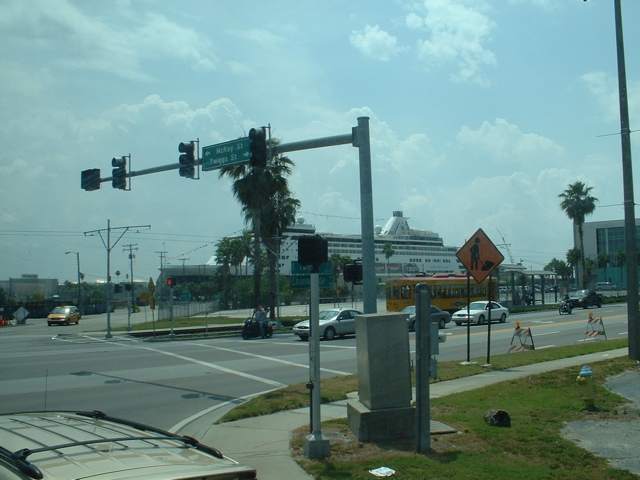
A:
[0, 304, 627, 433]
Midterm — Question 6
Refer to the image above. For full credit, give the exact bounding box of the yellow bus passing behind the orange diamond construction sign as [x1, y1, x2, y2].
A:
[385, 274, 498, 312]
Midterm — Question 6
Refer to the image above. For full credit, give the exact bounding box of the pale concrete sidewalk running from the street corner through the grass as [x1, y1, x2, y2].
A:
[180, 348, 640, 480]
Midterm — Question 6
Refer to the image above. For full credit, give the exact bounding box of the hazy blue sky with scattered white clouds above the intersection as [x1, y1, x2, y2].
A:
[0, 0, 640, 282]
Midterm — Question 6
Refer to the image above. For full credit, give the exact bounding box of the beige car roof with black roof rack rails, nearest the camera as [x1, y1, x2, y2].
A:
[0, 411, 256, 480]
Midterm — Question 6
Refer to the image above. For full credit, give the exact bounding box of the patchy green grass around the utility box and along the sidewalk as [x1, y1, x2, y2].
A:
[221, 340, 640, 480]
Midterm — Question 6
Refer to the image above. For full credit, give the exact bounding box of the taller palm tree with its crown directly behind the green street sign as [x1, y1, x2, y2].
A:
[219, 139, 299, 306]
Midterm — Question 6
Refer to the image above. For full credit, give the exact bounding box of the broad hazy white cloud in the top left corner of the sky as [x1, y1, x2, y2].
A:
[0, 0, 218, 80]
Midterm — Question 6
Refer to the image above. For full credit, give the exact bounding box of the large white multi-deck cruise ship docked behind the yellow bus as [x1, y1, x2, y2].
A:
[279, 211, 465, 279]
